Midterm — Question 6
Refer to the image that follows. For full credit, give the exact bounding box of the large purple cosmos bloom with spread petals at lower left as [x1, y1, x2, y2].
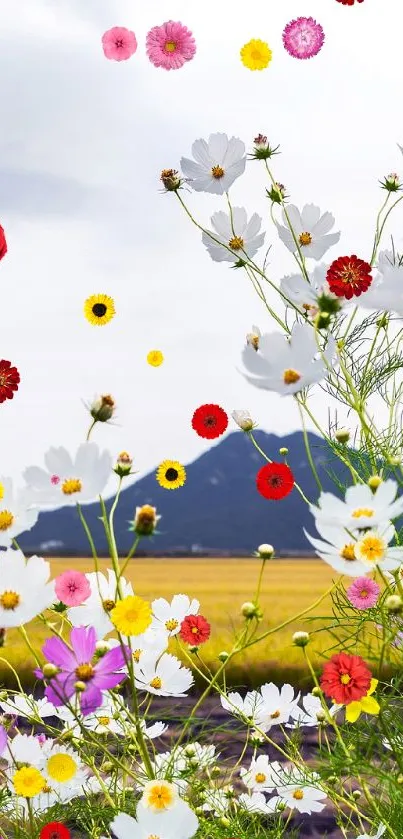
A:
[42, 626, 130, 717]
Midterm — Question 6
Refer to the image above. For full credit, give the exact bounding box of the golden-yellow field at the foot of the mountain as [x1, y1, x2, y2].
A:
[0, 558, 346, 686]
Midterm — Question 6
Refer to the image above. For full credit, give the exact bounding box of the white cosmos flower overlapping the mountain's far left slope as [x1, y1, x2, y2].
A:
[23, 443, 112, 510]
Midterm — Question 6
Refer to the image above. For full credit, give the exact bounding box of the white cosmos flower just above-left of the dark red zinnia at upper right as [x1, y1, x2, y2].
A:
[276, 204, 340, 259]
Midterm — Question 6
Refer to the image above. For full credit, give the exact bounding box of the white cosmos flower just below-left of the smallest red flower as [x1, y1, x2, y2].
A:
[135, 653, 194, 696]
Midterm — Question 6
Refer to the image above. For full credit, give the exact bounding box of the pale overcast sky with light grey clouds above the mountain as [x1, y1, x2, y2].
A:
[0, 0, 403, 492]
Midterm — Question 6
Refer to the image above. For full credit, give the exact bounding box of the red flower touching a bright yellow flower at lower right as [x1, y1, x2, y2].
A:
[320, 653, 372, 705]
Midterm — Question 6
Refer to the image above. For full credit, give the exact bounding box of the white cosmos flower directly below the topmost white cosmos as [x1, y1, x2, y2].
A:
[202, 207, 265, 263]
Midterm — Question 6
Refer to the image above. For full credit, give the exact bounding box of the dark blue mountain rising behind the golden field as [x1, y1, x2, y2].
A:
[18, 430, 350, 556]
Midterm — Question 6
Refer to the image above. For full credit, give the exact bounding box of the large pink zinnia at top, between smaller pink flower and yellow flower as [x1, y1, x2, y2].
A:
[146, 20, 196, 70]
